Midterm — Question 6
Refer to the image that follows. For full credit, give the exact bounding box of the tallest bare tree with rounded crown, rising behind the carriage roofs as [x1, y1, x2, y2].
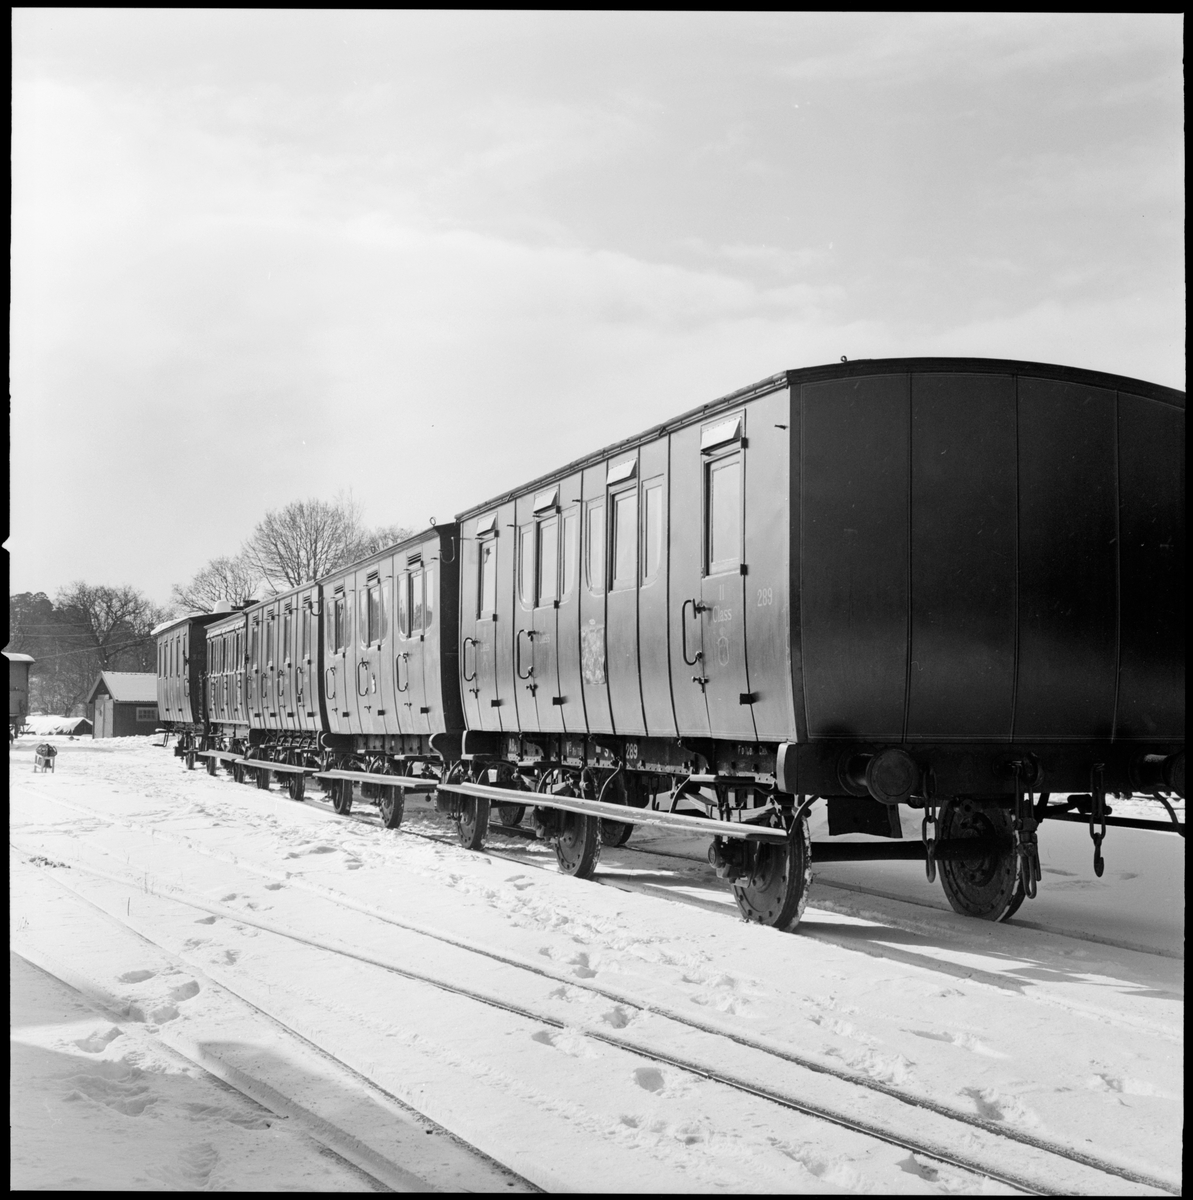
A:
[241, 496, 407, 592]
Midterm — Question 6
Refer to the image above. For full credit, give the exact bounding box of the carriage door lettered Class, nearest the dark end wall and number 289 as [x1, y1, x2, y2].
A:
[689, 413, 755, 742]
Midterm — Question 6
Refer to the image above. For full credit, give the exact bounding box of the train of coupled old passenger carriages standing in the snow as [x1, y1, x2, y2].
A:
[160, 359, 1185, 928]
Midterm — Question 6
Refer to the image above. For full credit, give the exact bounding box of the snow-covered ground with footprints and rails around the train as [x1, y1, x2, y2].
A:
[10, 738, 1183, 1195]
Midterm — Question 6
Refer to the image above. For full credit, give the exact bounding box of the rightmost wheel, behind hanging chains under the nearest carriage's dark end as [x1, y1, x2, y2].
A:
[936, 797, 1025, 920]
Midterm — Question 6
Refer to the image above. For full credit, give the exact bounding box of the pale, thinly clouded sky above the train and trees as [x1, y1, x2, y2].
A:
[10, 8, 1185, 601]
